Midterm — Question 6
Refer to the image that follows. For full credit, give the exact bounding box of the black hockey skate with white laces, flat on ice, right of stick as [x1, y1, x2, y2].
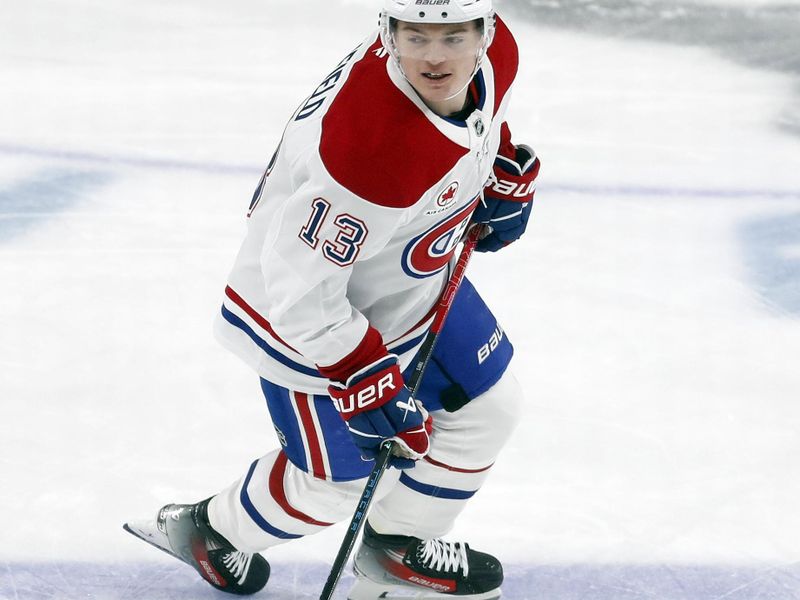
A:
[347, 523, 503, 600]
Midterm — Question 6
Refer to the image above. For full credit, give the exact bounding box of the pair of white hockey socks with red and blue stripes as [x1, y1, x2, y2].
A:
[208, 371, 522, 552]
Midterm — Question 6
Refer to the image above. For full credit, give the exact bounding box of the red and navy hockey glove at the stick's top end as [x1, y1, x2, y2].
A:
[472, 145, 539, 252]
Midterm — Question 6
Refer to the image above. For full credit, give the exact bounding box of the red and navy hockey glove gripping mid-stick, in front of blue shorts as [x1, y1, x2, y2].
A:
[328, 354, 432, 469]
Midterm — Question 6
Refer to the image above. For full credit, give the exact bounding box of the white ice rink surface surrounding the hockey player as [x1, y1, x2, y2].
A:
[0, 0, 800, 600]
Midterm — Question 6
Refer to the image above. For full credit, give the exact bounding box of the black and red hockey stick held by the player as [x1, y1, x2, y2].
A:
[319, 224, 485, 600]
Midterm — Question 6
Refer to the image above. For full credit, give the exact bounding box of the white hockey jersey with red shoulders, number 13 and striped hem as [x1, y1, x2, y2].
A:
[215, 18, 518, 394]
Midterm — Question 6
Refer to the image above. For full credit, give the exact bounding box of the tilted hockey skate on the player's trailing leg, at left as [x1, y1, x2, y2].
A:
[123, 500, 269, 595]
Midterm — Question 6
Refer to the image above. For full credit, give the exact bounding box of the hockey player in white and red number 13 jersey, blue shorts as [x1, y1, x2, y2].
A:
[125, 0, 539, 600]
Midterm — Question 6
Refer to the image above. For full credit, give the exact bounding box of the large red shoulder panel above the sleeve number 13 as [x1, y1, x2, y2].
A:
[319, 39, 466, 208]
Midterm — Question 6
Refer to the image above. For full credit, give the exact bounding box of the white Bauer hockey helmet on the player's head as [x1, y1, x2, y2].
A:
[380, 0, 495, 98]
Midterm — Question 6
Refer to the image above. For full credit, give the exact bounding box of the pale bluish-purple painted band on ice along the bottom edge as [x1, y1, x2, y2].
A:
[0, 561, 800, 600]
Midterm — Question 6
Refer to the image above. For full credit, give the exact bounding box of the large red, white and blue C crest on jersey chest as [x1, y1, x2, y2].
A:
[403, 198, 478, 279]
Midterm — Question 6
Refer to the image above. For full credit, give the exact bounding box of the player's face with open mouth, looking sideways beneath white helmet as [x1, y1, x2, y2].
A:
[394, 21, 482, 115]
